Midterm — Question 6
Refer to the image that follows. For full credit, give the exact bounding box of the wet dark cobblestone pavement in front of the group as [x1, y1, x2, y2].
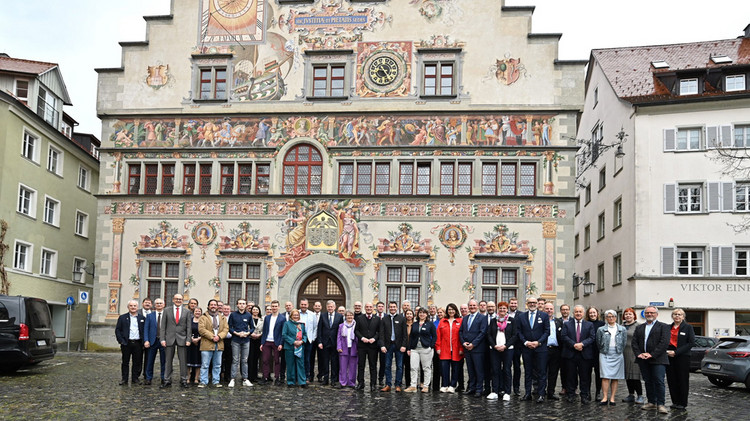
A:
[0, 353, 750, 421]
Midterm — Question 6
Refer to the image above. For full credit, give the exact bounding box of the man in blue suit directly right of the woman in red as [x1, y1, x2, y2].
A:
[458, 300, 488, 398]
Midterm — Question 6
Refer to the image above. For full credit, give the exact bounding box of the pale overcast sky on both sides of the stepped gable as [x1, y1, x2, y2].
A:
[0, 0, 750, 137]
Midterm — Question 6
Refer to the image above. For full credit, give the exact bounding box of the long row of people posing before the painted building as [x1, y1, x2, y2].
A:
[116, 294, 695, 413]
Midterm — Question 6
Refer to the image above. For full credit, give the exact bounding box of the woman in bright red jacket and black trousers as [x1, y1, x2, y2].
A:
[435, 303, 464, 393]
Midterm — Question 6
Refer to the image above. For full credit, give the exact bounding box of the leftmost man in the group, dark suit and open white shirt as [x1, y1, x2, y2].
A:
[115, 300, 146, 386]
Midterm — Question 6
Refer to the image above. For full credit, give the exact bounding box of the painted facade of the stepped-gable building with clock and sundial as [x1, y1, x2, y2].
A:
[92, 0, 585, 343]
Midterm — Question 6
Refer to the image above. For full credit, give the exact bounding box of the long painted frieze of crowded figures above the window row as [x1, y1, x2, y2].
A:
[109, 114, 563, 148]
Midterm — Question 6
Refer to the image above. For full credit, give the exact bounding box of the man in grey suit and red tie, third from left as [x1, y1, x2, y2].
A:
[159, 294, 193, 387]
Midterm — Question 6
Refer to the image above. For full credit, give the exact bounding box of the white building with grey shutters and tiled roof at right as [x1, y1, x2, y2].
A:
[574, 26, 750, 336]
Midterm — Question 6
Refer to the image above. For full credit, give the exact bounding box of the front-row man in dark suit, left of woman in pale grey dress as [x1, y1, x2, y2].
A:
[562, 305, 596, 405]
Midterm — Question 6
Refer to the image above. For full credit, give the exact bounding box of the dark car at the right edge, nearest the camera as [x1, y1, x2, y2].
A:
[701, 336, 750, 389]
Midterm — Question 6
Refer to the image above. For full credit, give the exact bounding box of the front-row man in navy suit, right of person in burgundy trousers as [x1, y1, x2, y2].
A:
[516, 297, 549, 403]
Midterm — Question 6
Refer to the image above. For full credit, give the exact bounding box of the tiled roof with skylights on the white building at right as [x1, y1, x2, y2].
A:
[589, 37, 750, 102]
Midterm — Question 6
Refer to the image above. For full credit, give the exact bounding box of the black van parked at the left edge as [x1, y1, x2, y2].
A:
[0, 295, 57, 373]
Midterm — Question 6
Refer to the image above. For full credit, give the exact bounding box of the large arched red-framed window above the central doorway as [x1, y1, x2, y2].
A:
[283, 144, 323, 194]
